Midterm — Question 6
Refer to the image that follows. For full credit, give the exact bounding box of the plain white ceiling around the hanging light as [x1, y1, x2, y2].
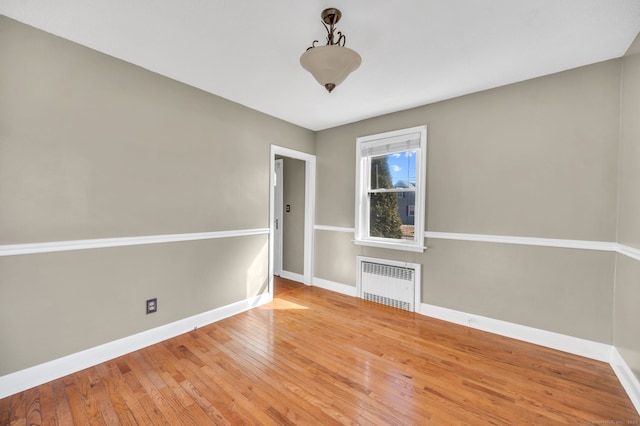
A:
[0, 0, 640, 130]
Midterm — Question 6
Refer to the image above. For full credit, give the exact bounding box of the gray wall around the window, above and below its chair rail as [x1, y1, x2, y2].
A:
[314, 60, 621, 344]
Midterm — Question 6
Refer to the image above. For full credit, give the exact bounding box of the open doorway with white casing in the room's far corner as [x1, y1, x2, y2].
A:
[269, 145, 316, 297]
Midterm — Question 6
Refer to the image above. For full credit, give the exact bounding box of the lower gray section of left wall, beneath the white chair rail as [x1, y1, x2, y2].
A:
[0, 235, 268, 375]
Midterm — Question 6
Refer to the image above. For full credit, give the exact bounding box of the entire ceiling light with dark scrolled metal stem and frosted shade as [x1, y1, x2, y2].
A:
[300, 7, 362, 93]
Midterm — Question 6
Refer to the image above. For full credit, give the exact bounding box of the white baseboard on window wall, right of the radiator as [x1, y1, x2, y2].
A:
[420, 303, 612, 362]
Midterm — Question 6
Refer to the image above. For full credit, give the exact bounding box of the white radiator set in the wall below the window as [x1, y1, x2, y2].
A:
[361, 261, 415, 312]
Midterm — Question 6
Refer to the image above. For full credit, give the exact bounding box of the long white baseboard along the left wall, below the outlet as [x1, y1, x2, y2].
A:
[0, 293, 271, 399]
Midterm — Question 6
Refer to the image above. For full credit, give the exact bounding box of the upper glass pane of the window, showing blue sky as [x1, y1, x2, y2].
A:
[371, 150, 416, 189]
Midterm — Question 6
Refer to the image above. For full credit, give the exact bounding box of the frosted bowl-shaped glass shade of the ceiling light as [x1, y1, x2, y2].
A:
[300, 45, 362, 92]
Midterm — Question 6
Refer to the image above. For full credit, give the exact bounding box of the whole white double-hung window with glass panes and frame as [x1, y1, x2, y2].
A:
[355, 126, 427, 251]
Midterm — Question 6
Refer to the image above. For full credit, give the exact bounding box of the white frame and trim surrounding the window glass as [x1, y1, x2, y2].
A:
[354, 126, 427, 252]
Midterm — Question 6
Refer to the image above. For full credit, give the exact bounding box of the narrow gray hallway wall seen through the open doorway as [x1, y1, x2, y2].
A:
[282, 157, 305, 275]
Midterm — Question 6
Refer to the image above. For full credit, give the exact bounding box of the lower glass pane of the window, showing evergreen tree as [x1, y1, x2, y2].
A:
[369, 191, 416, 241]
